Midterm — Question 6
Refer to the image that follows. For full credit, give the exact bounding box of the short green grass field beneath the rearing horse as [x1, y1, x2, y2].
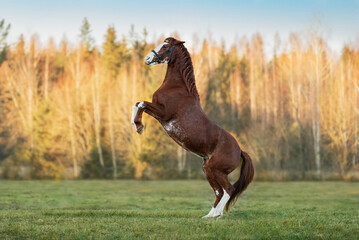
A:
[0, 181, 359, 240]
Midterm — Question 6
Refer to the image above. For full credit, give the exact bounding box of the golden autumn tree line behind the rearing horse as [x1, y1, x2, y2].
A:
[0, 18, 359, 180]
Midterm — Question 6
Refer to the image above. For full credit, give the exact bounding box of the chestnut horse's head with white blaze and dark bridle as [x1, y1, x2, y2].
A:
[145, 37, 184, 66]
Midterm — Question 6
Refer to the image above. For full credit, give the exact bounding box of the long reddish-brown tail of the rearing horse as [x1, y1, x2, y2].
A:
[226, 151, 254, 212]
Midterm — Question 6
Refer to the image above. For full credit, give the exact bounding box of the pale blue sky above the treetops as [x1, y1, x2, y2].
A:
[0, 0, 359, 54]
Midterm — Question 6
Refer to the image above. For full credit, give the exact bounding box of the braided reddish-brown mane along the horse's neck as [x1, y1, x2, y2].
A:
[177, 44, 199, 99]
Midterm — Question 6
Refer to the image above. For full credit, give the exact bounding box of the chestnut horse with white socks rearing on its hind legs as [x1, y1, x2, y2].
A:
[131, 37, 254, 218]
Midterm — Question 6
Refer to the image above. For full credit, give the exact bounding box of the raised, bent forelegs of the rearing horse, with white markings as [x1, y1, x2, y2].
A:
[131, 101, 165, 134]
